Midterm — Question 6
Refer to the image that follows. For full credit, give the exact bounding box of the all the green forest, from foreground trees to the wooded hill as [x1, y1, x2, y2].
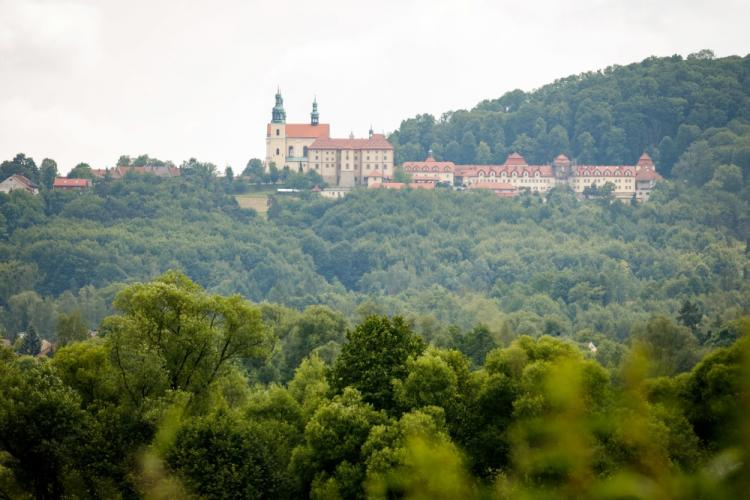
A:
[0, 53, 750, 498]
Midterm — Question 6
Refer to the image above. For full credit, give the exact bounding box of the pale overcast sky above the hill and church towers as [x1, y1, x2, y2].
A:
[0, 0, 750, 172]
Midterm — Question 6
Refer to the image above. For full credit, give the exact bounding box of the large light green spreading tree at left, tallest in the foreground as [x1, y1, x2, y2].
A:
[102, 271, 271, 404]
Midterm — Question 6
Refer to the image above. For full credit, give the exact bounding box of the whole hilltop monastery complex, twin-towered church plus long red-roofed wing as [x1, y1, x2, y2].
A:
[265, 92, 662, 201]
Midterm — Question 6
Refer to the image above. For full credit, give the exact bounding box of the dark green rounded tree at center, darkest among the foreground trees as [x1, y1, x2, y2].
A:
[329, 316, 425, 412]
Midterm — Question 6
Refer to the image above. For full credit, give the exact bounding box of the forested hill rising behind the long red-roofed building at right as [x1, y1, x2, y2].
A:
[389, 51, 750, 175]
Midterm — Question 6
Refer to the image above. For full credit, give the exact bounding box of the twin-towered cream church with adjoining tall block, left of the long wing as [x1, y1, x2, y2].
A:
[265, 91, 393, 187]
